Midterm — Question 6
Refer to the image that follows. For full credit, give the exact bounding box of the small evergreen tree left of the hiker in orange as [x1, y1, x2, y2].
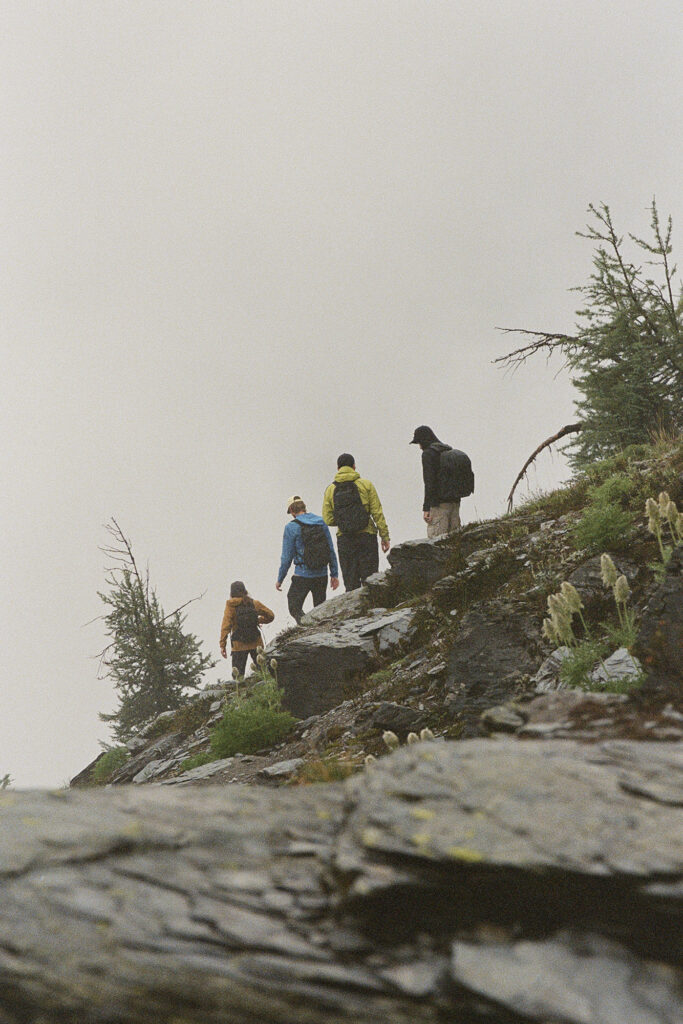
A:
[98, 519, 215, 741]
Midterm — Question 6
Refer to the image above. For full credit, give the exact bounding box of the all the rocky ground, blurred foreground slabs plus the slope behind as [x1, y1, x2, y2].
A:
[5, 436, 683, 1024]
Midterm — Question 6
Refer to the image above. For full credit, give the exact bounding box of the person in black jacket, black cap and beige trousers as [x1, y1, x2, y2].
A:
[411, 426, 474, 538]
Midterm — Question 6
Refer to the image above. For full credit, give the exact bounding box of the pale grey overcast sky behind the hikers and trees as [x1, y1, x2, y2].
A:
[0, 0, 683, 786]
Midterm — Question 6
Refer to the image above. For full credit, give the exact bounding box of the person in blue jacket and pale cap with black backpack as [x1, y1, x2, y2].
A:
[275, 495, 339, 623]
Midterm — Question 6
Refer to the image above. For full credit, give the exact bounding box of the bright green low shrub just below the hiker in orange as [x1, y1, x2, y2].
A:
[211, 680, 296, 760]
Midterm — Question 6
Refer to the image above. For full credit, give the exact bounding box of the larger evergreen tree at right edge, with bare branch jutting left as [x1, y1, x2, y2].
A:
[497, 200, 683, 469]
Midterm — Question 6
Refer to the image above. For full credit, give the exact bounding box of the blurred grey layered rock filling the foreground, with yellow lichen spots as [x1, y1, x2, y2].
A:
[0, 739, 683, 1024]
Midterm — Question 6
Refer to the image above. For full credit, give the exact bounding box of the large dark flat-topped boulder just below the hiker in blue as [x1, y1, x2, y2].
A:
[266, 608, 416, 718]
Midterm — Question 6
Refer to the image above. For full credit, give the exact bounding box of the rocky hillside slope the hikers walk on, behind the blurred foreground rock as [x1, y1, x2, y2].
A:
[72, 442, 683, 786]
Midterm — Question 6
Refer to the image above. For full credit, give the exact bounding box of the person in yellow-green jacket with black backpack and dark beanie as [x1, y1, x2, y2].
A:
[323, 452, 391, 591]
